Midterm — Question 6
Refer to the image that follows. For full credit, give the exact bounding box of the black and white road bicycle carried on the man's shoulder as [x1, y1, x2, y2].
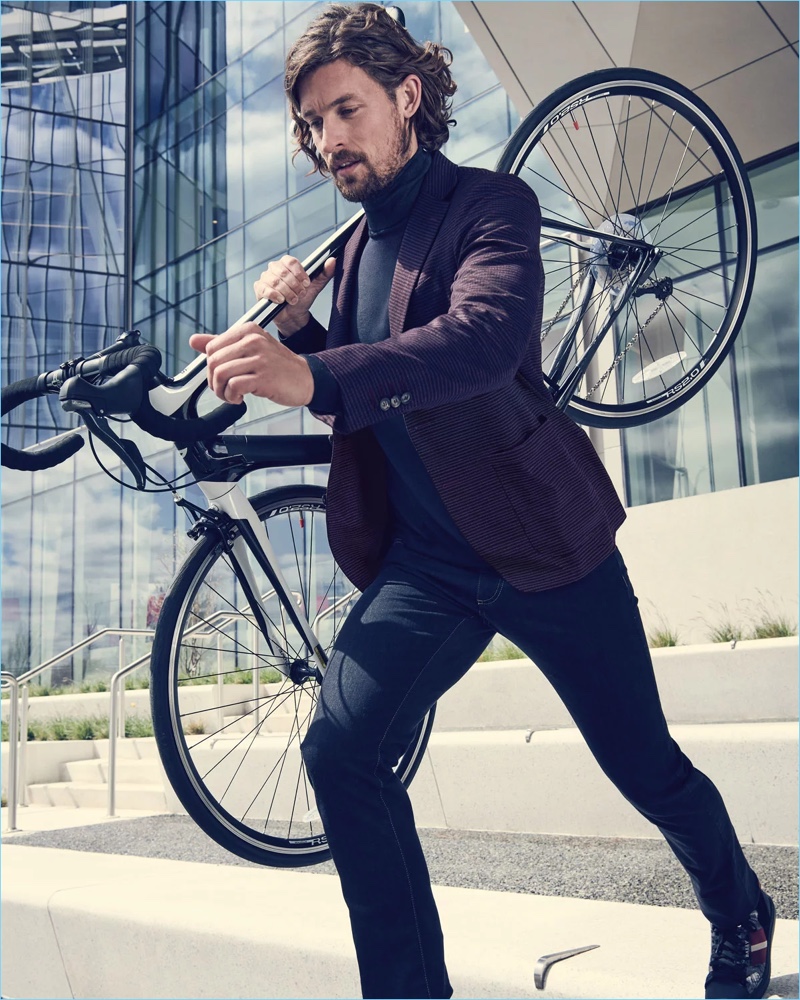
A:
[2, 70, 756, 866]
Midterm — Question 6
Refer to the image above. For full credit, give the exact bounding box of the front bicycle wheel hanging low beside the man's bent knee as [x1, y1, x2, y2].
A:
[150, 485, 435, 867]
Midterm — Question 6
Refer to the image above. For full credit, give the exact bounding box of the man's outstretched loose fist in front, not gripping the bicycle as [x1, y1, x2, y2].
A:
[189, 323, 314, 406]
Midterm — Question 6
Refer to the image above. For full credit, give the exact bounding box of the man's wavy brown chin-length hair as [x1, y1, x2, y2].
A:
[284, 3, 456, 174]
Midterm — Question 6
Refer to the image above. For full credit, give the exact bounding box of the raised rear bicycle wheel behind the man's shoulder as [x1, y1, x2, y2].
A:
[497, 69, 756, 428]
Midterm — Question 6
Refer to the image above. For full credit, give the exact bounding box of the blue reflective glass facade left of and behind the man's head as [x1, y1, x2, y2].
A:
[3, 0, 518, 682]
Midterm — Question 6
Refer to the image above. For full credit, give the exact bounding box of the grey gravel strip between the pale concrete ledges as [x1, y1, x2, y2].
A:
[7, 816, 798, 919]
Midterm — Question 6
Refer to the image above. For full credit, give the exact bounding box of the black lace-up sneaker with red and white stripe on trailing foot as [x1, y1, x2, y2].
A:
[706, 891, 775, 1000]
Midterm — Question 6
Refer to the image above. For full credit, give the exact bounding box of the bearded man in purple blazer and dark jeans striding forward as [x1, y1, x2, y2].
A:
[191, 3, 775, 997]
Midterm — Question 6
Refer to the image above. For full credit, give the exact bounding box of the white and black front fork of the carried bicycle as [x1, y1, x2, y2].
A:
[197, 482, 328, 684]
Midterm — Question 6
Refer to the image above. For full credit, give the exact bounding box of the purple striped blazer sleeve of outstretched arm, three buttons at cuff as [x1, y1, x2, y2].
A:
[310, 174, 543, 434]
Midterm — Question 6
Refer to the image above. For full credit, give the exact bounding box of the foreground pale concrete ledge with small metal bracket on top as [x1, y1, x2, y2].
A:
[2, 845, 798, 998]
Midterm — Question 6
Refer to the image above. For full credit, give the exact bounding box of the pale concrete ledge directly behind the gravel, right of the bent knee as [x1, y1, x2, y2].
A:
[411, 722, 798, 844]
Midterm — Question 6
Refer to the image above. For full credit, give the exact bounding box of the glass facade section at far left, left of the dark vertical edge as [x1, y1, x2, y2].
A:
[2, 3, 127, 674]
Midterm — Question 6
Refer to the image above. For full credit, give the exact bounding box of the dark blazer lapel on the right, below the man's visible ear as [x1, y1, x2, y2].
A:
[389, 153, 458, 337]
